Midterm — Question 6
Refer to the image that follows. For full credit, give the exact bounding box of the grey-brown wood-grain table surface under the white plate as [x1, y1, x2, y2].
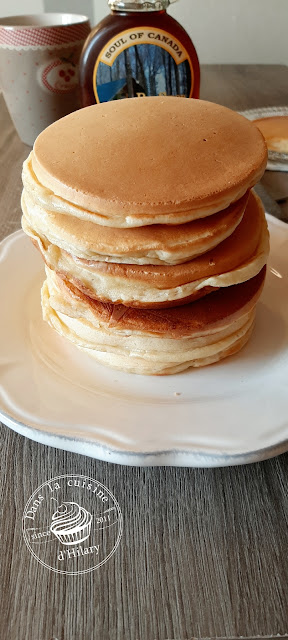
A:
[0, 65, 288, 640]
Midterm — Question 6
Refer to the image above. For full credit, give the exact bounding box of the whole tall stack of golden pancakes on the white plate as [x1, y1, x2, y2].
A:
[22, 97, 269, 374]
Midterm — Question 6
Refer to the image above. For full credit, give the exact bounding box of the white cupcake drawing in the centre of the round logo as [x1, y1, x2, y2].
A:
[50, 502, 92, 545]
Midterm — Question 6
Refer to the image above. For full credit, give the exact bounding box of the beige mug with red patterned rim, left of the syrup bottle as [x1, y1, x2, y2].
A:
[0, 13, 90, 145]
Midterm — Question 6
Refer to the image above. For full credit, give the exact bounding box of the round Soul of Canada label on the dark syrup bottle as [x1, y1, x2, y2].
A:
[93, 27, 194, 103]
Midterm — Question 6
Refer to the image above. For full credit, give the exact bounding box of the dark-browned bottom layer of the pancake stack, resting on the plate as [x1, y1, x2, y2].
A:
[42, 267, 266, 375]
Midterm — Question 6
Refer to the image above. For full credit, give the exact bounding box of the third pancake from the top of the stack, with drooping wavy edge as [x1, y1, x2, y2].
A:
[22, 192, 269, 308]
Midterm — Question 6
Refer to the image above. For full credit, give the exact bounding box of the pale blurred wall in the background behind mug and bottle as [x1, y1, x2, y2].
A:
[0, 0, 288, 65]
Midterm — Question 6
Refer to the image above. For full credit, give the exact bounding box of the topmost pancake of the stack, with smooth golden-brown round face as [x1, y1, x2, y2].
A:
[27, 96, 267, 227]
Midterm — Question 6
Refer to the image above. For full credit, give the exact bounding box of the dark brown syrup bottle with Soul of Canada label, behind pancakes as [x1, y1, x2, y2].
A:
[79, 0, 200, 107]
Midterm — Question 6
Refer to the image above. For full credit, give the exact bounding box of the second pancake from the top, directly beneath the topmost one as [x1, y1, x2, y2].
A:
[21, 189, 249, 265]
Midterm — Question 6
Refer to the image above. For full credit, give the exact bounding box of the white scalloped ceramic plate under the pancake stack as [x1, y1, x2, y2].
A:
[0, 216, 288, 467]
